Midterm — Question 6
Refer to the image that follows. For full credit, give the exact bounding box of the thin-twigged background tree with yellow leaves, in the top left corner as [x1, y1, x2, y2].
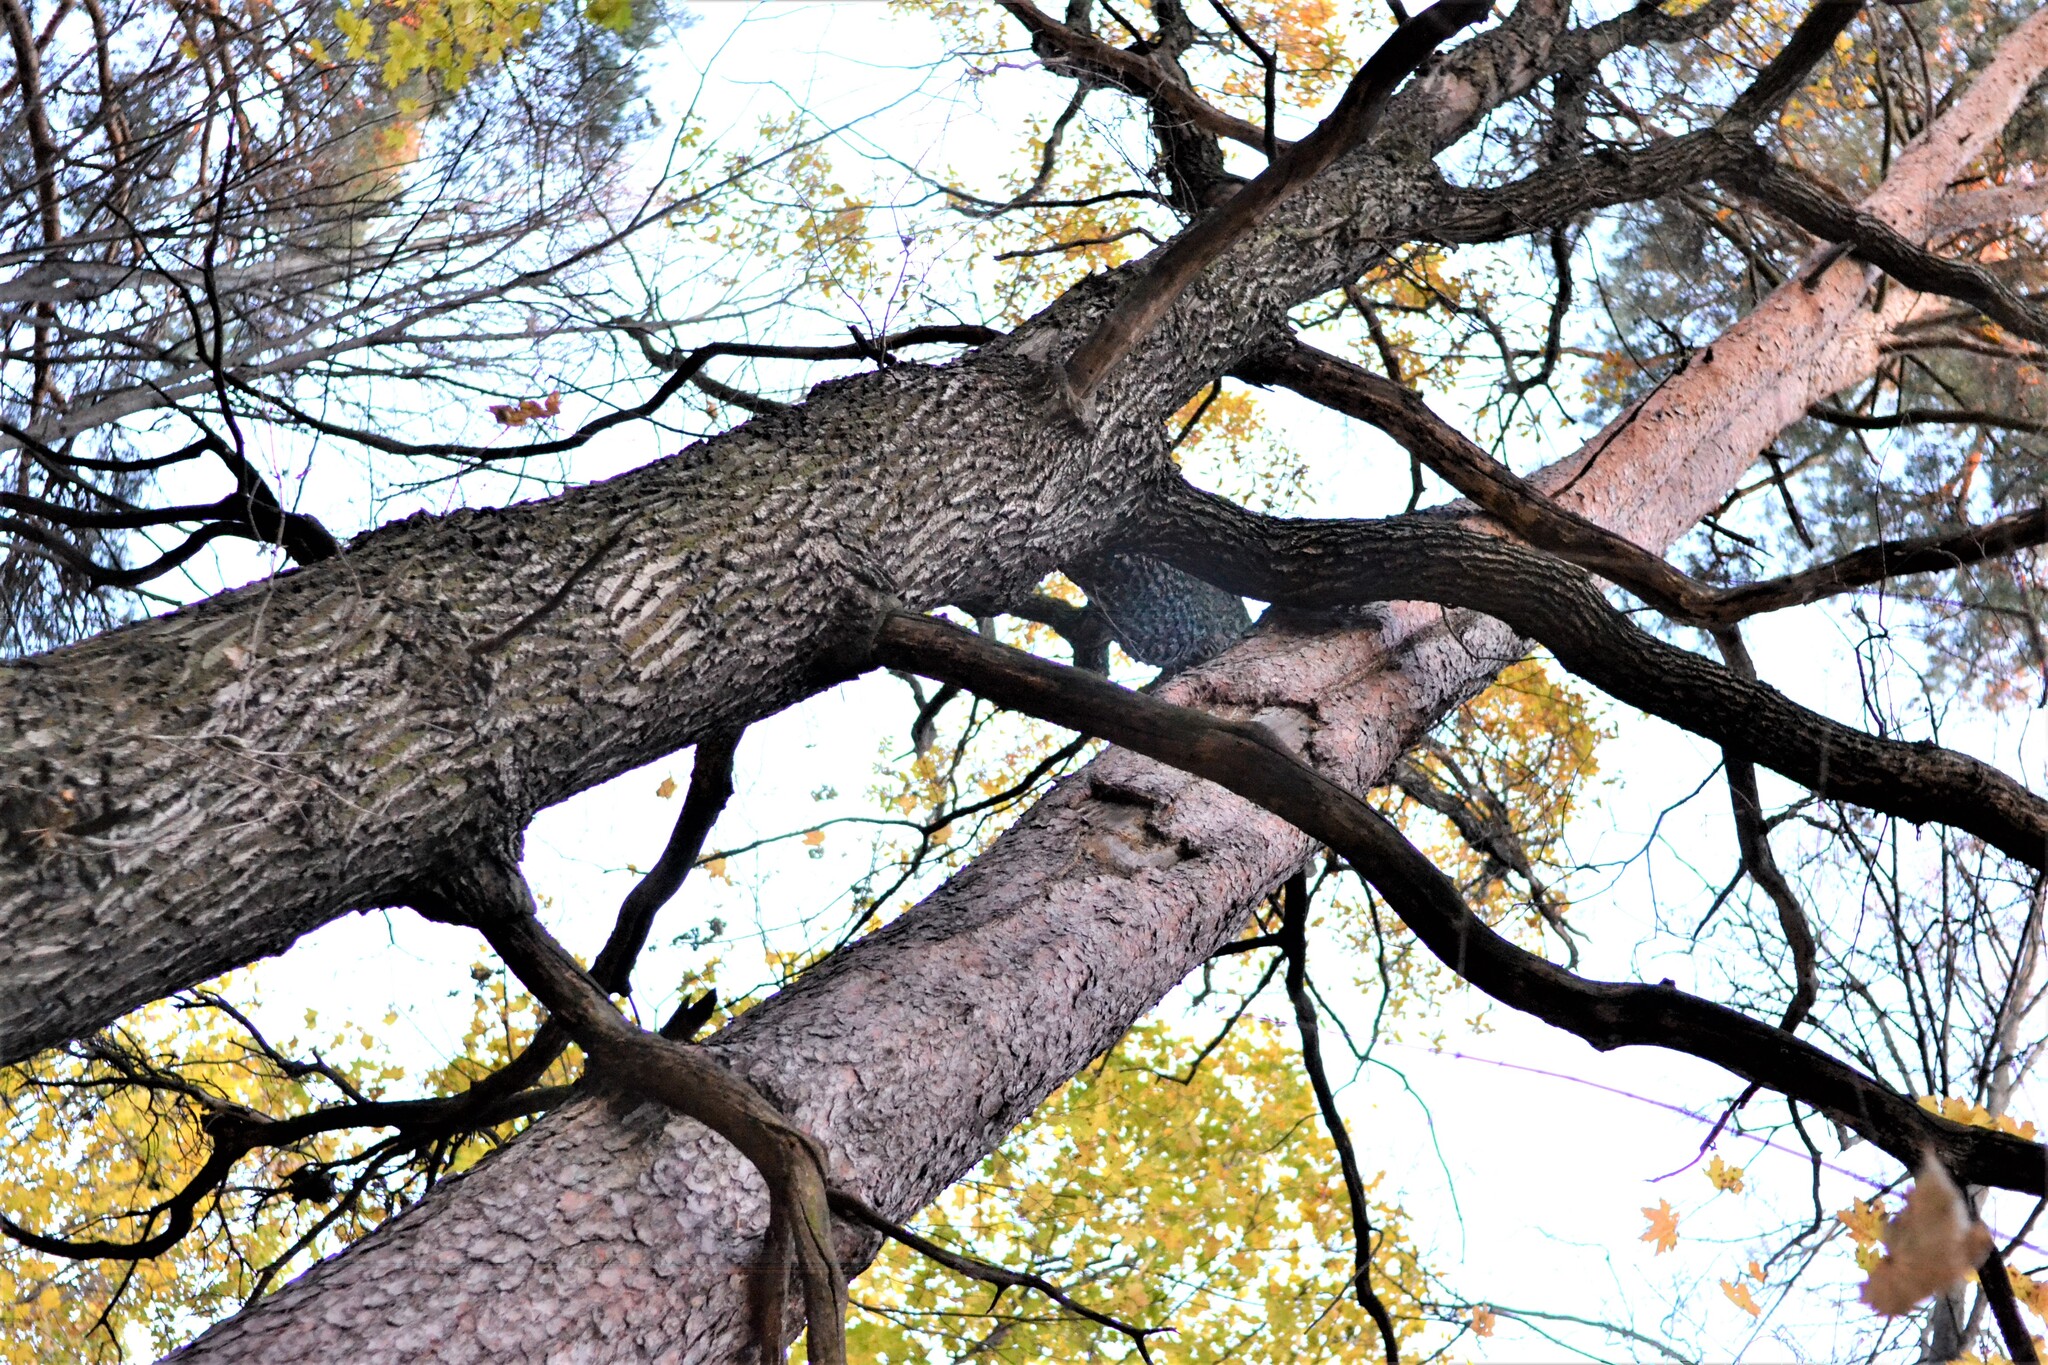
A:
[0, 0, 688, 653]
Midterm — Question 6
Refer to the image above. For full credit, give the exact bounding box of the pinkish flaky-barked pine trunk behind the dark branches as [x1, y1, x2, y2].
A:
[167, 12, 2048, 1365]
